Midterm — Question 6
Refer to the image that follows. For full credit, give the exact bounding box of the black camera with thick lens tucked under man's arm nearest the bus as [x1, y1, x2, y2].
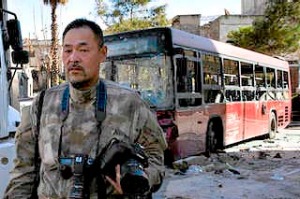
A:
[100, 139, 150, 195]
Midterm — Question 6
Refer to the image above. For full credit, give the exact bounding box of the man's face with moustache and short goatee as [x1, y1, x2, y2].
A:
[62, 27, 107, 90]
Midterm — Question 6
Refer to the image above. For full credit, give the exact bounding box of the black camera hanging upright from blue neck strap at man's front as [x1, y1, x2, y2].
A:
[59, 154, 93, 198]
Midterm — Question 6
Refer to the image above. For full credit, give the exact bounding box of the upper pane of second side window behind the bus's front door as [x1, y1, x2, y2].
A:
[224, 59, 239, 86]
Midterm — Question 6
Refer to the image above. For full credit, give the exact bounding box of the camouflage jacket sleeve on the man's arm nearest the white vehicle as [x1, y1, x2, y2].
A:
[4, 94, 41, 199]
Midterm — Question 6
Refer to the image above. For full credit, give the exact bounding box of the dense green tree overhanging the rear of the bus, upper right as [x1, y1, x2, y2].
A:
[228, 0, 300, 56]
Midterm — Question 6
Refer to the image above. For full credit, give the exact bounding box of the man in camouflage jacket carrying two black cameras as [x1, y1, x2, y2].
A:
[5, 19, 166, 198]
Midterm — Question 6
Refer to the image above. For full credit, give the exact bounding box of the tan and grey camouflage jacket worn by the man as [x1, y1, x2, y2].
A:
[4, 81, 166, 198]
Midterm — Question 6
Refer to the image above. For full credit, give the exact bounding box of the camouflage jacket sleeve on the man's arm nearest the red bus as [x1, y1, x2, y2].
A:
[138, 103, 167, 192]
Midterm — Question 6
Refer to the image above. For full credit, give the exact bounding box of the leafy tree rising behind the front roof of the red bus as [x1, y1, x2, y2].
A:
[97, 0, 169, 33]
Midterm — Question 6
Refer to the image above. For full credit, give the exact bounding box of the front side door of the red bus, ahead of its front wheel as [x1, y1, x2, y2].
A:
[173, 49, 205, 159]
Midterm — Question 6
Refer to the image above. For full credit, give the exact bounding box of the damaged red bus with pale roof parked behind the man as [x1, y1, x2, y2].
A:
[100, 27, 291, 160]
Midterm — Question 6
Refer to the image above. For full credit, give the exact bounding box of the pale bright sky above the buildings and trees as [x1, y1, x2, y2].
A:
[7, 0, 241, 39]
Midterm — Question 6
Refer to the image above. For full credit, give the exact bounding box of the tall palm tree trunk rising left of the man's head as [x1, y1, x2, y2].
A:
[44, 0, 68, 86]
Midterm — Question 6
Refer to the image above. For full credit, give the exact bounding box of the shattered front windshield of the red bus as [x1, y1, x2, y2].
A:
[100, 55, 173, 108]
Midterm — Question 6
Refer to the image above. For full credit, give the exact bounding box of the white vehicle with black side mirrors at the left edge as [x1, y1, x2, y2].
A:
[0, 0, 28, 198]
